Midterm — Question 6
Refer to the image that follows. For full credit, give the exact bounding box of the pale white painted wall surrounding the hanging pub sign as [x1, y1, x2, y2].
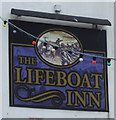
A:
[2, 2, 114, 118]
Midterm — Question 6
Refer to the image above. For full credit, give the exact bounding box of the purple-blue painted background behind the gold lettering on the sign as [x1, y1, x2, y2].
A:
[9, 44, 107, 111]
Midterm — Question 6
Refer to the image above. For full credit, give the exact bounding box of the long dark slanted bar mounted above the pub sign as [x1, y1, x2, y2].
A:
[11, 8, 111, 26]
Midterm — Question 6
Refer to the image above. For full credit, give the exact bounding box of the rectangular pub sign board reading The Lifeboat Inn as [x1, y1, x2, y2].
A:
[9, 20, 109, 111]
